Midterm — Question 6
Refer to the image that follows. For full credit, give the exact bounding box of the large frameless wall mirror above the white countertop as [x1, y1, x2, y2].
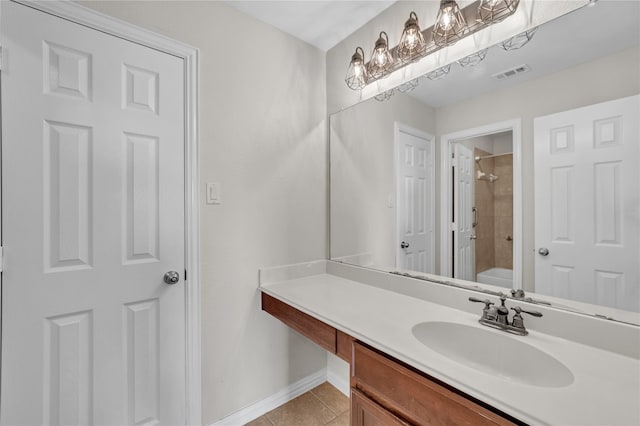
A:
[330, 0, 640, 324]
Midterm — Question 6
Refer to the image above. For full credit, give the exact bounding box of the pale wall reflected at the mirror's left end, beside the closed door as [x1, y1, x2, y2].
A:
[330, 94, 438, 267]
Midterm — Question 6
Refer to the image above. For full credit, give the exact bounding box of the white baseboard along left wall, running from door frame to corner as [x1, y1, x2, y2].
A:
[211, 368, 328, 426]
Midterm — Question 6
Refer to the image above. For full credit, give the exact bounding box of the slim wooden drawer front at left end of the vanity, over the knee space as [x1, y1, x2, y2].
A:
[262, 293, 336, 354]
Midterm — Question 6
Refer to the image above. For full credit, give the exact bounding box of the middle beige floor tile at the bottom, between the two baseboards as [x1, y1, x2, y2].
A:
[266, 392, 336, 426]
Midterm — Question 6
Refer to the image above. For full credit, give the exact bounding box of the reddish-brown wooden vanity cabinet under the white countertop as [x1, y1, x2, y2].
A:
[262, 293, 524, 426]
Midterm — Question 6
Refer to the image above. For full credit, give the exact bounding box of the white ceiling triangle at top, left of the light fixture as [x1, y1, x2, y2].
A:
[225, 0, 395, 51]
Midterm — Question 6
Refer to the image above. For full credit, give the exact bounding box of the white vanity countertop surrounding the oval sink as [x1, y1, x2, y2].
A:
[260, 262, 640, 426]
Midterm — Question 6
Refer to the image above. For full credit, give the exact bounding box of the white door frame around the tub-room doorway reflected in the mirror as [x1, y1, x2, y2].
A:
[440, 118, 523, 289]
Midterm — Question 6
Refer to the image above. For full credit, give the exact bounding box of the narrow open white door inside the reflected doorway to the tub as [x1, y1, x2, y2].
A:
[453, 143, 476, 281]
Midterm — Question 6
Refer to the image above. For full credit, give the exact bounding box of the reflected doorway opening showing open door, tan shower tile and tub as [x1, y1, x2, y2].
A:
[450, 131, 514, 288]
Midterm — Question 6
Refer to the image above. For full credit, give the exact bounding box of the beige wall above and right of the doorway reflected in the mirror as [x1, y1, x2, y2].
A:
[436, 48, 640, 291]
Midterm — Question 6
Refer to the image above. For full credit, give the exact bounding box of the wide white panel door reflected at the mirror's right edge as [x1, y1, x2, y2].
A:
[534, 96, 640, 311]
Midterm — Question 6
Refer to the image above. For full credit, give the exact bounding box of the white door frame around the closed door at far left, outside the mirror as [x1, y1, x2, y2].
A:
[0, 0, 202, 425]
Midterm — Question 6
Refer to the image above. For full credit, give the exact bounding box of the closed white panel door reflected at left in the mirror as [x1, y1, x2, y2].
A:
[396, 126, 435, 273]
